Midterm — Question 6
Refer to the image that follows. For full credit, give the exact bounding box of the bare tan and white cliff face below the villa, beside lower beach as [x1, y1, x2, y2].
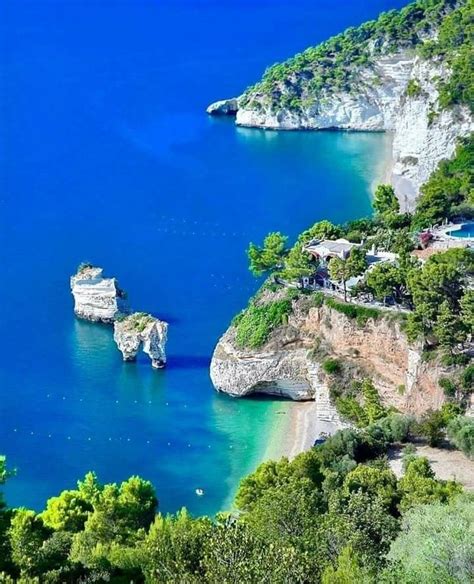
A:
[211, 301, 444, 416]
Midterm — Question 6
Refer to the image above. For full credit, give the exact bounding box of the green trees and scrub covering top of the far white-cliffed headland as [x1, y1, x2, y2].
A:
[240, 0, 474, 111]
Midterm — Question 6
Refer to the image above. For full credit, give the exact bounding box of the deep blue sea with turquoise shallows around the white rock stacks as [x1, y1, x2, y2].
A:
[0, 0, 405, 513]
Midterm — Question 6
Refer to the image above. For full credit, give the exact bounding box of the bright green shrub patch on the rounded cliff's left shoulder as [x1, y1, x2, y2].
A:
[233, 299, 292, 349]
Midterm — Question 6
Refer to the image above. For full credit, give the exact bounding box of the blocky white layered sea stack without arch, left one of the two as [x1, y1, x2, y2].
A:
[71, 264, 129, 323]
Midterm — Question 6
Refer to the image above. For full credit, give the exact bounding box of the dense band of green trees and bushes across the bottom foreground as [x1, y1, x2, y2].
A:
[0, 414, 472, 584]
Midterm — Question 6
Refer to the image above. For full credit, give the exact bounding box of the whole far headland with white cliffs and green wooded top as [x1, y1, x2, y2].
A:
[208, 0, 474, 211]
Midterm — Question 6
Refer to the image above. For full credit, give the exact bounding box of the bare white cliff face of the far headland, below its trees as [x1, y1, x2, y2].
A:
[231, 50, 474, 210]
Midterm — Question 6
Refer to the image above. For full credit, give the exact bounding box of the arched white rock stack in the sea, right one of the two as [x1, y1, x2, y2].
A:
[114, 312, 168, 369]
